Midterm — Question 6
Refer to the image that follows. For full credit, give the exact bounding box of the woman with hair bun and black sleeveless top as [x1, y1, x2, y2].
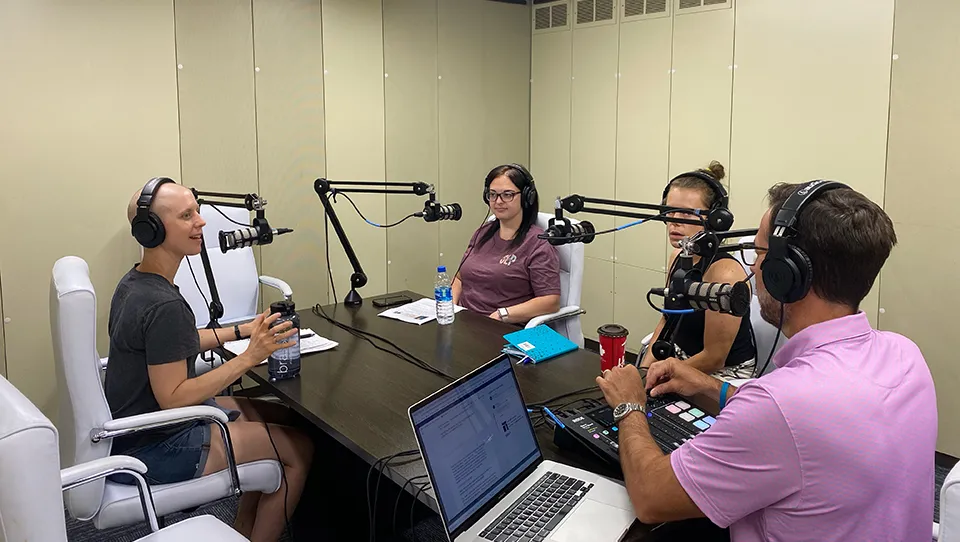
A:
[640, 161, 757, 379]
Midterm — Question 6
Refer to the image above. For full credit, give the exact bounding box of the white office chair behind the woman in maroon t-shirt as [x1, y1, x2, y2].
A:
[487, 213, 584, 348]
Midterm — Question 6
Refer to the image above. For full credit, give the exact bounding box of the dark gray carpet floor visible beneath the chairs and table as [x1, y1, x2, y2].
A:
[66, 466, 949, 542]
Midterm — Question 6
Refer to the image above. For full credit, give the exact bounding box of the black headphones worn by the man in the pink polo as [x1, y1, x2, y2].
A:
[760, 179, 850, 303]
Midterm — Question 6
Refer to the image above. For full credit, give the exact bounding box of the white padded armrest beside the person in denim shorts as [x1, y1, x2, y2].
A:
[90, 405, 240, 495]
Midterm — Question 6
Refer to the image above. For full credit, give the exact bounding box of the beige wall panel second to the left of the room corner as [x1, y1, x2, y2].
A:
[383, 0, 440, 295]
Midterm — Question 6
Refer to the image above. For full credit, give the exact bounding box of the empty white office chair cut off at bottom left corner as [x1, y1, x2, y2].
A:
[0, 376, 246, 542]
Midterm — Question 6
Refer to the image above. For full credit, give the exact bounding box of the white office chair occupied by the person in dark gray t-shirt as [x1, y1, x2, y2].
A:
[51, 256, 281, 529]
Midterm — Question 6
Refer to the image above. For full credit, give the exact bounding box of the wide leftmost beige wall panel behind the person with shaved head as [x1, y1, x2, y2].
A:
[0, 0, 180, 420]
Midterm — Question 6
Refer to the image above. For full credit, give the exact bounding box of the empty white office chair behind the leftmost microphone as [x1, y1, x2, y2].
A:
[173, 205, 293, 375]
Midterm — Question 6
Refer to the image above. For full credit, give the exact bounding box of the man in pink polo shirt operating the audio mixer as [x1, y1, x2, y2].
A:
[597, 181, 937, 542]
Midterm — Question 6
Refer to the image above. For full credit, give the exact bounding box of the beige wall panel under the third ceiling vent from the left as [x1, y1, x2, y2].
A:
[614, 18, 673, 271]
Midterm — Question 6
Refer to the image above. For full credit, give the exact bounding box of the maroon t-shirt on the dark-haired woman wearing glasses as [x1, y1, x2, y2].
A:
[457, 223, 560, 315]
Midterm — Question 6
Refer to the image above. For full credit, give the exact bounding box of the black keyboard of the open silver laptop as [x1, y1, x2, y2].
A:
[480, 472, 593, 542]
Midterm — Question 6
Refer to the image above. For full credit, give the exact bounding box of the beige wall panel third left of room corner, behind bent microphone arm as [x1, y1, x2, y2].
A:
[321, 0, 387, 301]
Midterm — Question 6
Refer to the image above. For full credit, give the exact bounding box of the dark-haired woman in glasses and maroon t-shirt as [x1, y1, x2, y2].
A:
[453, 164, 560, 324]
